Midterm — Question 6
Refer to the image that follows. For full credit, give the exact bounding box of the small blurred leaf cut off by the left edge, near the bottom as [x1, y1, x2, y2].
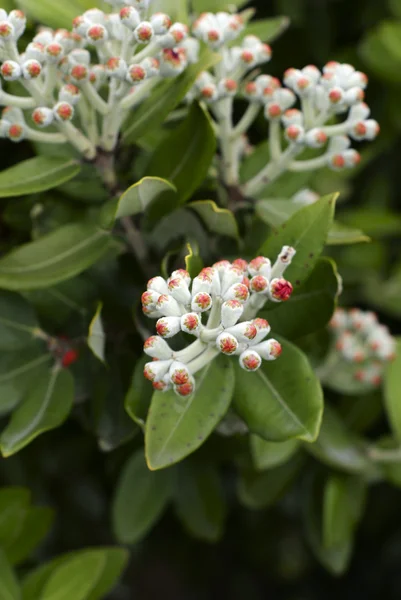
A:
[0, 487, 31, 546]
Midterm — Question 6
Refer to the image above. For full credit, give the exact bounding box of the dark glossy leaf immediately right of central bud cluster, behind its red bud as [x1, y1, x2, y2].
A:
[261, 258, 340, 339]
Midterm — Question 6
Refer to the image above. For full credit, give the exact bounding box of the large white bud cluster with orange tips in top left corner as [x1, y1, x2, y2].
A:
[0, 0, 195, 158]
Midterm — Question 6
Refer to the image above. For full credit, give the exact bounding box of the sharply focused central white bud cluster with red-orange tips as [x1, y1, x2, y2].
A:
[142, 246, 295, 396]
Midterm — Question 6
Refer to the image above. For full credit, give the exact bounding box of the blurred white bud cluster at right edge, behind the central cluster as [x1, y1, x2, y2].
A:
[330, 308, 396, 386]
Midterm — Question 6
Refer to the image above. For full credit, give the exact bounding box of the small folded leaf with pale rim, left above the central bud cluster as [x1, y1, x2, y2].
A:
[114, 177, 176, 220]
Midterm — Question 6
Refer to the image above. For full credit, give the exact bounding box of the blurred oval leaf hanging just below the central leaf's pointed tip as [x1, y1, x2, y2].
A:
[113, 450, 171, 544]
